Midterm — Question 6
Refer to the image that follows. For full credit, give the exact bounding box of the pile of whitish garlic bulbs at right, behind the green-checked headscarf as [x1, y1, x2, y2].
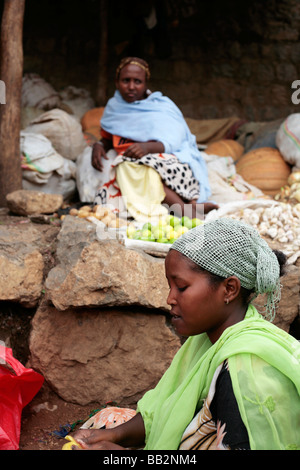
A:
[230, 203, 300, 264]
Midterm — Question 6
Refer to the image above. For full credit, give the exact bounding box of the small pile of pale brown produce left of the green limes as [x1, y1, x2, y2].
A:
[64, 205, 128, 229]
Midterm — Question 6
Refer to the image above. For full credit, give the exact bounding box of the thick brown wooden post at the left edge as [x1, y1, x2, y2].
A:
[0, 0, 25, 206]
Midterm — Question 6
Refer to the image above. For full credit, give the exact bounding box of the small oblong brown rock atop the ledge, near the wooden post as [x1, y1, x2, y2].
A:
[6, 189, 63, 215]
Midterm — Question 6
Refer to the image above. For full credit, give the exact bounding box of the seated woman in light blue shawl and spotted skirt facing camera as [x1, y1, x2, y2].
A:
[92, 57, 216, 217]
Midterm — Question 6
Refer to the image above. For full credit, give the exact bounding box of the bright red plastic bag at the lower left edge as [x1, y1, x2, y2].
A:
[0, 342, 44, 450]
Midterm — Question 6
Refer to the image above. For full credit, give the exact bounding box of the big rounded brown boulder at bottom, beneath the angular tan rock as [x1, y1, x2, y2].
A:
[30, 303, 180, 405]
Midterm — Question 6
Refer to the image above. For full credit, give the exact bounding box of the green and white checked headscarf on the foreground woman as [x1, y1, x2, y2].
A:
[172, 218, 280, 321]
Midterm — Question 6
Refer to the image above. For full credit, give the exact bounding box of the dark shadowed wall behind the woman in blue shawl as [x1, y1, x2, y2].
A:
[15, 0, 300, 121]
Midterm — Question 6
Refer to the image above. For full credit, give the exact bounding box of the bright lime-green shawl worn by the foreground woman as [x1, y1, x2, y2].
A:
[137, 305, 300, 450]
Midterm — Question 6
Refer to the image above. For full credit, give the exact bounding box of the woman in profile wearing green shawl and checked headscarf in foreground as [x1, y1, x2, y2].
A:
[75, 218, 300, 450]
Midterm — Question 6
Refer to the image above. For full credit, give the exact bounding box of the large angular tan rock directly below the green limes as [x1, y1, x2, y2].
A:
[45, 216, 169, 311]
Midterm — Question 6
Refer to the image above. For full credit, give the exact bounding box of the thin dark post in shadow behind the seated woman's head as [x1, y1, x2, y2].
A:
[96, 0, 108, 106]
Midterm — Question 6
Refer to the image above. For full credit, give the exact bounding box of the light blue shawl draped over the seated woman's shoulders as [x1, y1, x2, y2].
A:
[101, 90, 211, 203]
